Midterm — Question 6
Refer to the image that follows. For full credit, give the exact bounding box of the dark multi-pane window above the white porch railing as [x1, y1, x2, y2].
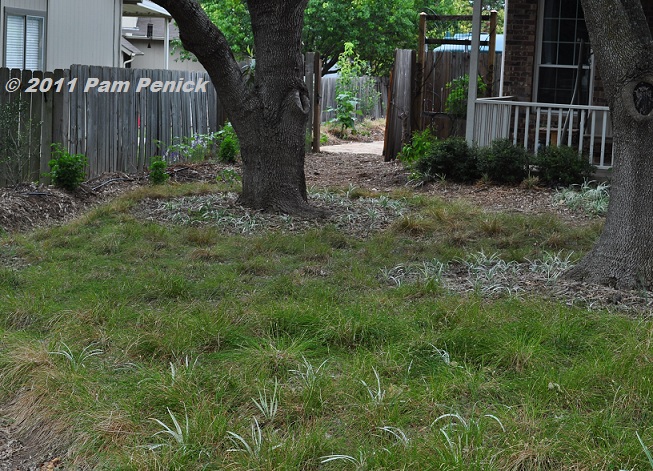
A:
[537, 0, 592, 104]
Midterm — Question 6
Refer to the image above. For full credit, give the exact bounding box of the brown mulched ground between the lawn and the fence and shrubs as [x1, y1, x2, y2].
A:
[0, 152, 586, 232]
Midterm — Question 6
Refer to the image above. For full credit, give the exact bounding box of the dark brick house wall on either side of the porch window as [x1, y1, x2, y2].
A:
[503, 0, 653, 105]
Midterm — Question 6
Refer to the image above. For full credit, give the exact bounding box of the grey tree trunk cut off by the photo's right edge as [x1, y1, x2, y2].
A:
[568, 0, 653, 289]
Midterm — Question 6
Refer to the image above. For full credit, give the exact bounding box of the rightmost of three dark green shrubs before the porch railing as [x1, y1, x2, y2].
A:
[534, 146, 596, 186]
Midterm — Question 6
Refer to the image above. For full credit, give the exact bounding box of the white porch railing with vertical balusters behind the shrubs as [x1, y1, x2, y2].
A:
[474, 97, 612, 169]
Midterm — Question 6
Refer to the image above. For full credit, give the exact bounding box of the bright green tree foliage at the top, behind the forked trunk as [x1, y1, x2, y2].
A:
[177, 0, 504, 76]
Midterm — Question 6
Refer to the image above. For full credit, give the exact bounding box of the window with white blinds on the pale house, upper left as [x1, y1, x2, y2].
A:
[5, 13, 45, 70]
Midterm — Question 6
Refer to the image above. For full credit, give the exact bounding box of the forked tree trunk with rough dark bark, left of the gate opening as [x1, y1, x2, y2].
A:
[154, 0, 321, 216]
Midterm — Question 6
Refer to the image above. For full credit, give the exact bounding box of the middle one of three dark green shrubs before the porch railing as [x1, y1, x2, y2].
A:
[478, 139, 529, 184]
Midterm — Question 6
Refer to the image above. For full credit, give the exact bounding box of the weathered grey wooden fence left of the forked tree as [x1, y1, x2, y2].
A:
[0, 65, 224, 185]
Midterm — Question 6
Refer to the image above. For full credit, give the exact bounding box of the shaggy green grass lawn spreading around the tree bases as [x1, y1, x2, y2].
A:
[0, 185, 653, 471]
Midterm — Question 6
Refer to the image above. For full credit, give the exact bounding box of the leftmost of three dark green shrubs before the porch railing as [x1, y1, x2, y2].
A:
[412, 137, 481, 182]
